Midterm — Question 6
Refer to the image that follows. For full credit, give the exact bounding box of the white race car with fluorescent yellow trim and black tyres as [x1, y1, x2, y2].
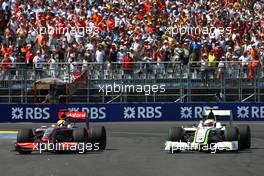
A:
[165, 109, 251, 153]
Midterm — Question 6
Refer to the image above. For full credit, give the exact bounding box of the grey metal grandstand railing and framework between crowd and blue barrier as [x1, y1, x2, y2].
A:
[0, 62, 264, 103]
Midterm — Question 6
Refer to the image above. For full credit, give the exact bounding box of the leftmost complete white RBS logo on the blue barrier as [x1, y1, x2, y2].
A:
[12, 107, 50, 120]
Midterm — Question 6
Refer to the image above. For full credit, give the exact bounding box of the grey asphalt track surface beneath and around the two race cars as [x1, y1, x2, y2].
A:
[0, 122, 264, 176]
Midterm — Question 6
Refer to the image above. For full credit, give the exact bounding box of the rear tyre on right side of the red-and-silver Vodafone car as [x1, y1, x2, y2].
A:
[90, 126, 106, 150]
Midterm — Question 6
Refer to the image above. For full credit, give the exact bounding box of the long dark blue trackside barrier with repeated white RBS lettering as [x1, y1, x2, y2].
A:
[0, 103, 264, 123]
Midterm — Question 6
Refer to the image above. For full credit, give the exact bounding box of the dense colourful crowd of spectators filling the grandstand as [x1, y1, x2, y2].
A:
[0, 0, 264, 79]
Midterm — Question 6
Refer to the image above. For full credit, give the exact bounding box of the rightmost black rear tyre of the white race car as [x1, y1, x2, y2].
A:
[237, 125, 251, 149]
